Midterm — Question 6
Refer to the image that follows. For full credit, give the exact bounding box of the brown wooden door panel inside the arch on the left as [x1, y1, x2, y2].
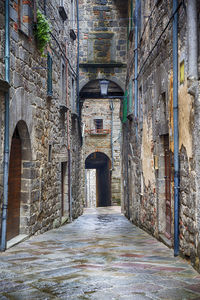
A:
[7, 129, 21, 240]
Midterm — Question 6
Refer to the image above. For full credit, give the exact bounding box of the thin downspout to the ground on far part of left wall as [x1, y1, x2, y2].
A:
[65, 43, 72, 220]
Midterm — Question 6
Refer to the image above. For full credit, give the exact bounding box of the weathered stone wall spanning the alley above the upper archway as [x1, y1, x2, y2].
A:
[79, 0, 127, 90]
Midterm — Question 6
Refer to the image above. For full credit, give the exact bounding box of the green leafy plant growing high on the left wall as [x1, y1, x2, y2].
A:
[34, 9, 51, 54]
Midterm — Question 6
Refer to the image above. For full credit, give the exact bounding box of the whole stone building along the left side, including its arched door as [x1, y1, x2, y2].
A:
[0, 0, 83, 248]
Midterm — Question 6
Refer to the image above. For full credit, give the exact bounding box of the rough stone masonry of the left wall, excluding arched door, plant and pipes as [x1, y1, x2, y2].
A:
[0, 0, 83, 244]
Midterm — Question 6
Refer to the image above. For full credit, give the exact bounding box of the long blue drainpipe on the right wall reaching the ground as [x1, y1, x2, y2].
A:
[173, 0, 179, 256]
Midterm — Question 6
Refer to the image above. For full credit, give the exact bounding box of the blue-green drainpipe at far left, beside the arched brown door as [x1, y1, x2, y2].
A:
[1, 0, 10, 251]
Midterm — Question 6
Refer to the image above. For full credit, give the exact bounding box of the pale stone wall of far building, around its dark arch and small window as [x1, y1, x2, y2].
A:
[82, 99, 121, 204]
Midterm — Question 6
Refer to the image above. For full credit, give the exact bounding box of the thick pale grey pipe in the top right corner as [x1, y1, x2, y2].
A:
[187, 0, 198, 79]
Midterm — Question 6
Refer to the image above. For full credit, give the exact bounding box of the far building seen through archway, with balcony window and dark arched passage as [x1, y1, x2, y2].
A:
[82, 99, 121, 206]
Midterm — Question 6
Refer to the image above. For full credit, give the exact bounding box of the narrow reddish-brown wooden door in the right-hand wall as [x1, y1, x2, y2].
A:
[164, 135, 171, 238]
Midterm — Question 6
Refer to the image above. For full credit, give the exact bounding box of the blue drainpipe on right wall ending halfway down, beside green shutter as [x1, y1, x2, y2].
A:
[134, 0, 139, 140]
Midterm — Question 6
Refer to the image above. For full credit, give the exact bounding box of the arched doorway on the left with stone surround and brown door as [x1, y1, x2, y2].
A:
[7, 121, 33, 241]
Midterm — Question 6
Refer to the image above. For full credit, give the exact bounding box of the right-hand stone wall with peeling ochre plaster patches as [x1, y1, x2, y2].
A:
[122, 1, 199, 268]
